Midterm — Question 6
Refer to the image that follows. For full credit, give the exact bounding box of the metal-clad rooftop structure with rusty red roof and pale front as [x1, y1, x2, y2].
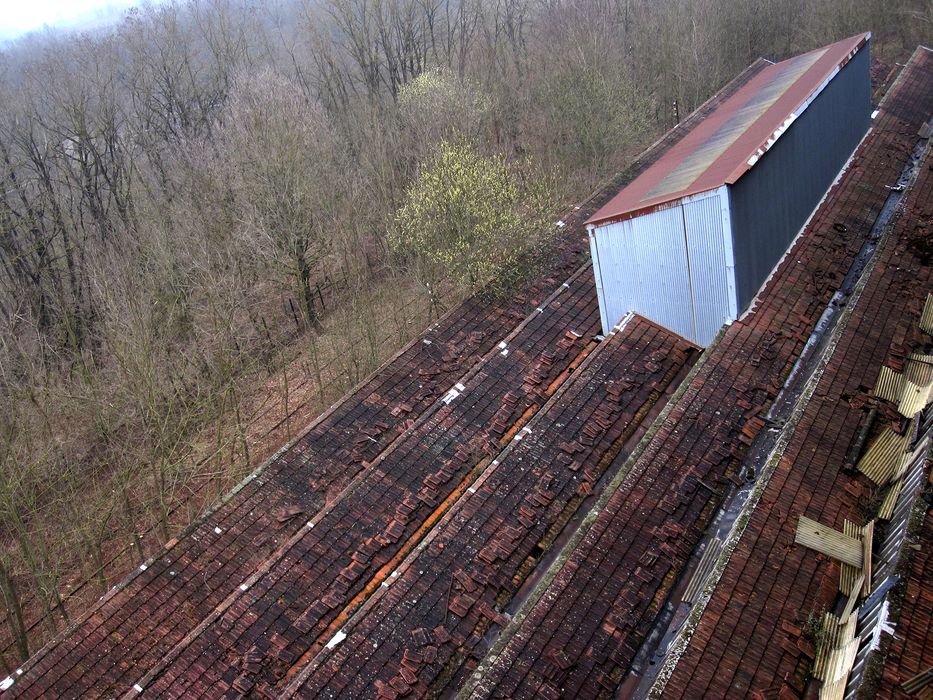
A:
[587, 33, 871, 345]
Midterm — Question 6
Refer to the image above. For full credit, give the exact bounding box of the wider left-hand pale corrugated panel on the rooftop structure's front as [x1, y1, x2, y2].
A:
[594, 203, 693, 338]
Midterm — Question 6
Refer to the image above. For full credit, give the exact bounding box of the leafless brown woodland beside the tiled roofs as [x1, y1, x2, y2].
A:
[0, 0, 933, 669]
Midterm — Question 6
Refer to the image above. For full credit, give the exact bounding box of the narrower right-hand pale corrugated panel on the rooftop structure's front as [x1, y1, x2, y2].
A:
[683, 193, 732, 346]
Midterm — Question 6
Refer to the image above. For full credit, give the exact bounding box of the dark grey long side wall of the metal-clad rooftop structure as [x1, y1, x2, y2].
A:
[730, 41, 871, 313]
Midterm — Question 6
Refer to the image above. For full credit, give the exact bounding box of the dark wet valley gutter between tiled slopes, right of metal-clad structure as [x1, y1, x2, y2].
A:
[617, 133, 927, 698]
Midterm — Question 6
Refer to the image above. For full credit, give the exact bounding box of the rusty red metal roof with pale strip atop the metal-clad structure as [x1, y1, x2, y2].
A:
[588, 33, 871, 224]
